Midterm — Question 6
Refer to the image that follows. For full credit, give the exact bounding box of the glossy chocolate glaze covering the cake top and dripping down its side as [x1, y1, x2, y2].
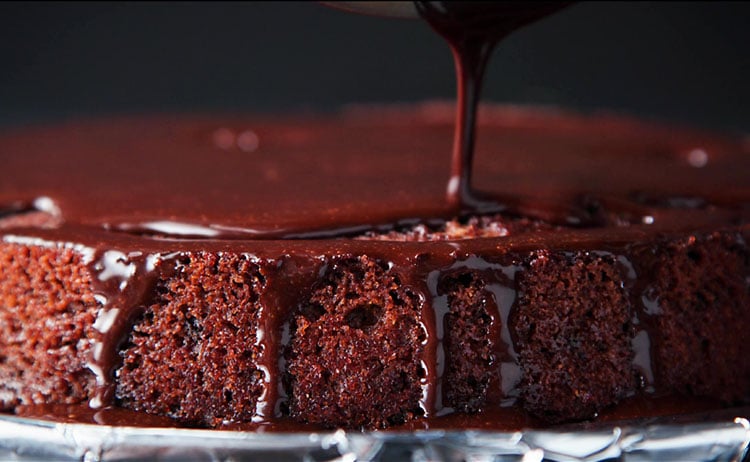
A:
[0, 106, 750, 428]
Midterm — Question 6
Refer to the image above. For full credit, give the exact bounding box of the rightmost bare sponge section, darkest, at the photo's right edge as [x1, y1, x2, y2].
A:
[641, 232, 750, 403]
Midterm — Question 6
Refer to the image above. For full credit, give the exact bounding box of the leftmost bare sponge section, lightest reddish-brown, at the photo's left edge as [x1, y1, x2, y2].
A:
[0, 241, 99, 410]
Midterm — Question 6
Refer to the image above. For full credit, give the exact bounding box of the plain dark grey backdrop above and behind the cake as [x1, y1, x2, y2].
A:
[0, 2, 750, 132]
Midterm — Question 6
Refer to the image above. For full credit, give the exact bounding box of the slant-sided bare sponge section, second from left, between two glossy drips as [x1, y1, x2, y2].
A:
[116, 252, 266, 427]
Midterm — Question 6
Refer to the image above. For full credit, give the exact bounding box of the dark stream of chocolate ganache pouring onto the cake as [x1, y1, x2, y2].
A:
[414, 1, 568, 212]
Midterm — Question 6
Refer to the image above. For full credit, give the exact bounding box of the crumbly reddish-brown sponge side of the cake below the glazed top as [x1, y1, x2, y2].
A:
[0, 224, 750, 428]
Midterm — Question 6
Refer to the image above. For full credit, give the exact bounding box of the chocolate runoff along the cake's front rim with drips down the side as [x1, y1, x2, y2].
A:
[4, 213, 748, 430]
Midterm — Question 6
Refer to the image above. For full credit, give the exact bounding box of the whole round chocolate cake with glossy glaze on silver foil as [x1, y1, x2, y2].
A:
[0, 105, 750, 429]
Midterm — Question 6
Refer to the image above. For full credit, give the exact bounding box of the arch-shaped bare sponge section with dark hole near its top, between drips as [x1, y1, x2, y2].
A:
[287, 256, 426, 428]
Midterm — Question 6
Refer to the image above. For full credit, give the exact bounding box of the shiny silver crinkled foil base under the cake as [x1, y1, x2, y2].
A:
[0, 416, 750, 462]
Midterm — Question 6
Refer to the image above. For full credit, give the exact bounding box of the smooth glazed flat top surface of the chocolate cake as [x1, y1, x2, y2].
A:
[0, 104, 750, 238]
